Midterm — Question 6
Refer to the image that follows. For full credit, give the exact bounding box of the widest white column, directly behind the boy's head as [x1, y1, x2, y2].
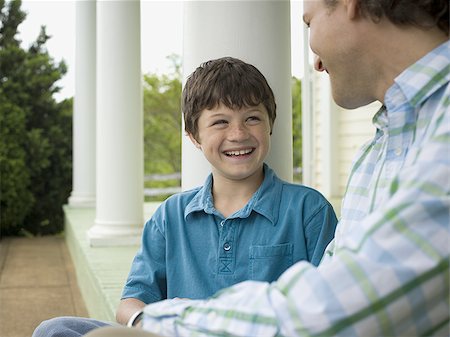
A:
[182, 1, 292, 190]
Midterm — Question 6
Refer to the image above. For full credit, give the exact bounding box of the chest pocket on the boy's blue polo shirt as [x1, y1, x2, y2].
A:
[249, 243, 294, 282]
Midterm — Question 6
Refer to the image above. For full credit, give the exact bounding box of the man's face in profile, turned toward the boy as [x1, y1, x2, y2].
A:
[303, 0, 376, 109]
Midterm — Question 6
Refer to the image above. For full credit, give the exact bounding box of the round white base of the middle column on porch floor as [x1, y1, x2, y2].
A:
[87, 221, 142, 247]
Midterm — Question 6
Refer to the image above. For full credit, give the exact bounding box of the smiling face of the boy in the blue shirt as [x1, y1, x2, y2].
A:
[189, 104, 270, 180]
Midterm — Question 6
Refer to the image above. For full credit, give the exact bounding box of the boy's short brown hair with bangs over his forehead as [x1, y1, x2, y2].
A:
[181, 57, 276, 139]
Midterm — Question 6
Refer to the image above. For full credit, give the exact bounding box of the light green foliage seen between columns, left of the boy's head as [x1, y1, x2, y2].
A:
[144, 55, 181, 199]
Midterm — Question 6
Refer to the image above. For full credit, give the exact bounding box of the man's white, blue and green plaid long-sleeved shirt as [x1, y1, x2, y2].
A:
[144, 42, 450, 337]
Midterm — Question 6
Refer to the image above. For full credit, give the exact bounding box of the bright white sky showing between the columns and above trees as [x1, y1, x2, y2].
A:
[18, 0, 303, 101]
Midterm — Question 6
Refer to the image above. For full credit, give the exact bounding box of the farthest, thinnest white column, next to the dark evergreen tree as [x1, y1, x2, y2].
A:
[69, 0, 95, 207]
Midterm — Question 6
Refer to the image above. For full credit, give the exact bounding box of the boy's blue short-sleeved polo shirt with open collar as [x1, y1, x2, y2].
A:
[122, 165, 337, 303]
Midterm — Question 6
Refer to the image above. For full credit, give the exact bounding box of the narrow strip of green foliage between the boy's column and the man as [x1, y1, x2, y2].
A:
[292, 77, 302, 182]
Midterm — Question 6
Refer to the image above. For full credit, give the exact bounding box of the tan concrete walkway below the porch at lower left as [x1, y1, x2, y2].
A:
[0, 236, 87, 337]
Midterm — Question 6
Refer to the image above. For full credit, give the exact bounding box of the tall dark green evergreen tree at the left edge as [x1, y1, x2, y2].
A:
[0, 0, 72, 235]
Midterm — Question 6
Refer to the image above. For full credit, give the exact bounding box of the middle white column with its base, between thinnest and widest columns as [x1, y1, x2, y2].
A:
[88, 0, 144, 246]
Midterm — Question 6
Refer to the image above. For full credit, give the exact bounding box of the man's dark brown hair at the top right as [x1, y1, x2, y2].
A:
[325, 0, 449, 36]
